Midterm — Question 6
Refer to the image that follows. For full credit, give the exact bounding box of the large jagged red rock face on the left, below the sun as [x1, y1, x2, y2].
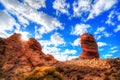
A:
[0, 33, 57, 76]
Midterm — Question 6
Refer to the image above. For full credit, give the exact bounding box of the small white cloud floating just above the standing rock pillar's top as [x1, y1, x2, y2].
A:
[71, 24, 91, 35]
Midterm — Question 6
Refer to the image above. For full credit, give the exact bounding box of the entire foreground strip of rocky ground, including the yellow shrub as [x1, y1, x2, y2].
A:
[0, 58, 120, 80]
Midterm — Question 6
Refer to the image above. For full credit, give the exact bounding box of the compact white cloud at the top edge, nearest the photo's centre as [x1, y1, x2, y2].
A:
[53, 0, 70, 15]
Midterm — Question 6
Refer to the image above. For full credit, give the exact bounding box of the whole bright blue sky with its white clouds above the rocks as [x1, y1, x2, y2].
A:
[0, 0, 120, 61]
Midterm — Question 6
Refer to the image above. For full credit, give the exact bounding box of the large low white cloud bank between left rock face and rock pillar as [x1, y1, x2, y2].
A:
[40, 33, 77, 61]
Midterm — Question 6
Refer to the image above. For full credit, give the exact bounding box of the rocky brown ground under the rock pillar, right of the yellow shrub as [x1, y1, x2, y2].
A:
[56, 58, 120, 80]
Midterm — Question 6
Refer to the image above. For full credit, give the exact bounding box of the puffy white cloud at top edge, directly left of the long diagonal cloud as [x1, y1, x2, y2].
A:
[73, 0, 92, 17]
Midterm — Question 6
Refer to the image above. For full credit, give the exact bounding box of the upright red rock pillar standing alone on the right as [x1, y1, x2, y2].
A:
[80, 33, 99, 59]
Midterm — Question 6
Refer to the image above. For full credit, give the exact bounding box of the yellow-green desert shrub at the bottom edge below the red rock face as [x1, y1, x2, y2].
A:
[19, 66, 64, 80]
